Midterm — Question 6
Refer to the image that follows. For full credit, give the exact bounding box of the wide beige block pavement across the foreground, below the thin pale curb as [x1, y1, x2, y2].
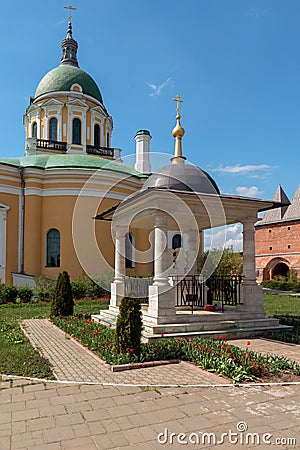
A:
[0, 380, 300, 450]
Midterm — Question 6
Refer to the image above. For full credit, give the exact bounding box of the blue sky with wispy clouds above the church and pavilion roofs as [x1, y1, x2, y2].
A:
[0, 0, 300, 209]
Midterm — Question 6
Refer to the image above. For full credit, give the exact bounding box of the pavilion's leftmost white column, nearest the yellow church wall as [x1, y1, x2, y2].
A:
[110, 226, 127, 309]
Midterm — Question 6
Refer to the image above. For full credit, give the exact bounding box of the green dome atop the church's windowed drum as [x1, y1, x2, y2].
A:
[34, 65, 103, 104]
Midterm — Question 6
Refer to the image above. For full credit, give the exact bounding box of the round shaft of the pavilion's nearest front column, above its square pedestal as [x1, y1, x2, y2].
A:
[153, 214, 169, 286]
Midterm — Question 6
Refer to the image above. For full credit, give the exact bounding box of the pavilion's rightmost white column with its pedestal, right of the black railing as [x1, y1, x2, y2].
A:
[240, 217, 265, 319]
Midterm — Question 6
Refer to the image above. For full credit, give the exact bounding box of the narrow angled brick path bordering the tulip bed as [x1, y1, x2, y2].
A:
[21, 319, 228, 386]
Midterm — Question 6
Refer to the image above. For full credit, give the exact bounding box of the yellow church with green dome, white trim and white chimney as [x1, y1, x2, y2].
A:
[0, 20, 152, 285]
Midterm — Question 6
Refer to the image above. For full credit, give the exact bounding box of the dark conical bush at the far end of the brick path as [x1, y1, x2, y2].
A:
[50, 272, 74, 316]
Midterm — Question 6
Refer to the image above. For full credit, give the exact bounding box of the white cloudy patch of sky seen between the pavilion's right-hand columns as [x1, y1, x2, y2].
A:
[204, 223, 243, 252]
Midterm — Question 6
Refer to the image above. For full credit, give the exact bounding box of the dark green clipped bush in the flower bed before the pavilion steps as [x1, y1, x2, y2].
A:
[116, 297, 143, 357]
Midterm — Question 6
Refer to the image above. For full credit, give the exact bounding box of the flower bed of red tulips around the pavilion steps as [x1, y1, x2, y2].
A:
[52, 312, 300, 382]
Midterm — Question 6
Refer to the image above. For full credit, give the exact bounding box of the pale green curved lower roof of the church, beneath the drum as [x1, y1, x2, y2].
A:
[0, 154, 147, 179]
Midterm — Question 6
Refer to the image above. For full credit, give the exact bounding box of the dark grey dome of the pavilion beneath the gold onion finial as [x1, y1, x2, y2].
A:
[142, 164, 220, 194]
